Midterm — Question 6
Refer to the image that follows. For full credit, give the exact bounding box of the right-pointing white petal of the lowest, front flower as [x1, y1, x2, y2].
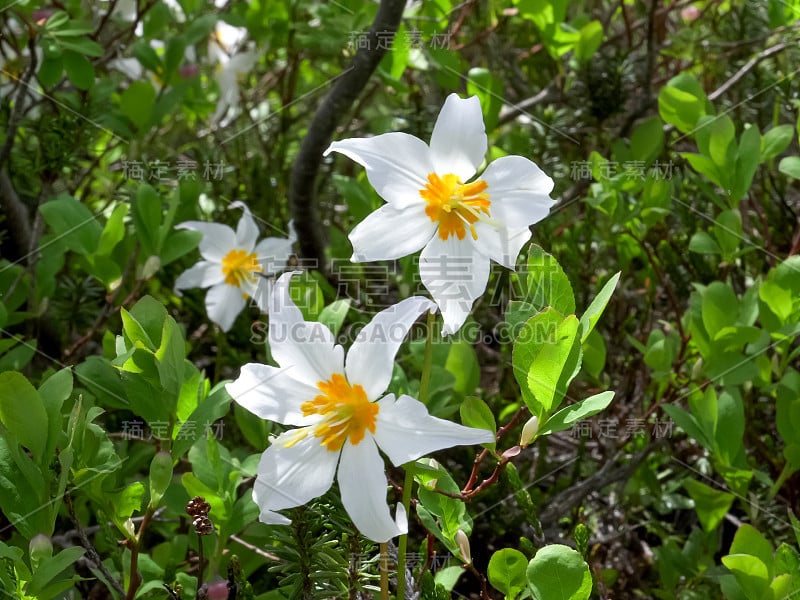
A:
[374, 394, 494, 467]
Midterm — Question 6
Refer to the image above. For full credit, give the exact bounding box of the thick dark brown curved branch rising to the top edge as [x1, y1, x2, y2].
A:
[289, 0, 405, 269]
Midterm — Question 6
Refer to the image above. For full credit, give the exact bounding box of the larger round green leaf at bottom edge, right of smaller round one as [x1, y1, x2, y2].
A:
[527, 544, 592, 600]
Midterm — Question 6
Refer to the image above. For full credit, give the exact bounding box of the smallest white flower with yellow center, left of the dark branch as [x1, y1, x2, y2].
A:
[175, 202, 296, 331]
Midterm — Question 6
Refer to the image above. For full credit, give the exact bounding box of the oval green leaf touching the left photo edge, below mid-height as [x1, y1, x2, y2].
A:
[0, 371, 48, 460]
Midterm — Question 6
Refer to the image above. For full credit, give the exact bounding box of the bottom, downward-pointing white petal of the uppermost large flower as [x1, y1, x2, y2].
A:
[419, 235, 490, 335]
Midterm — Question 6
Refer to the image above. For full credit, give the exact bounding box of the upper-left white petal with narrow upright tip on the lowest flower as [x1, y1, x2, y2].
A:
[269, 271, 344, 386]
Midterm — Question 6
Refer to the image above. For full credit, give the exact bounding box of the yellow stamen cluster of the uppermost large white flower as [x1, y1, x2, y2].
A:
[419, 173, 491, 240]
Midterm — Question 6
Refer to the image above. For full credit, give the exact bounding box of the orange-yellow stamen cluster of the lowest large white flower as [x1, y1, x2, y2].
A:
[286, 373, 380, 452]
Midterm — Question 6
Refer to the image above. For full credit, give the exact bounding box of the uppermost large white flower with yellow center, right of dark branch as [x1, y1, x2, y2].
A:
[325, 94, 555, 334]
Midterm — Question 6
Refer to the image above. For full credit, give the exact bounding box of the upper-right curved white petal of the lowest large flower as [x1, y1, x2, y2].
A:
[345, 296, 436, 400]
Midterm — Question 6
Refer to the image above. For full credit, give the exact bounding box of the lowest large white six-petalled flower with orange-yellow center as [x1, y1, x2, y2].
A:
[226, 273, 494, 542]
